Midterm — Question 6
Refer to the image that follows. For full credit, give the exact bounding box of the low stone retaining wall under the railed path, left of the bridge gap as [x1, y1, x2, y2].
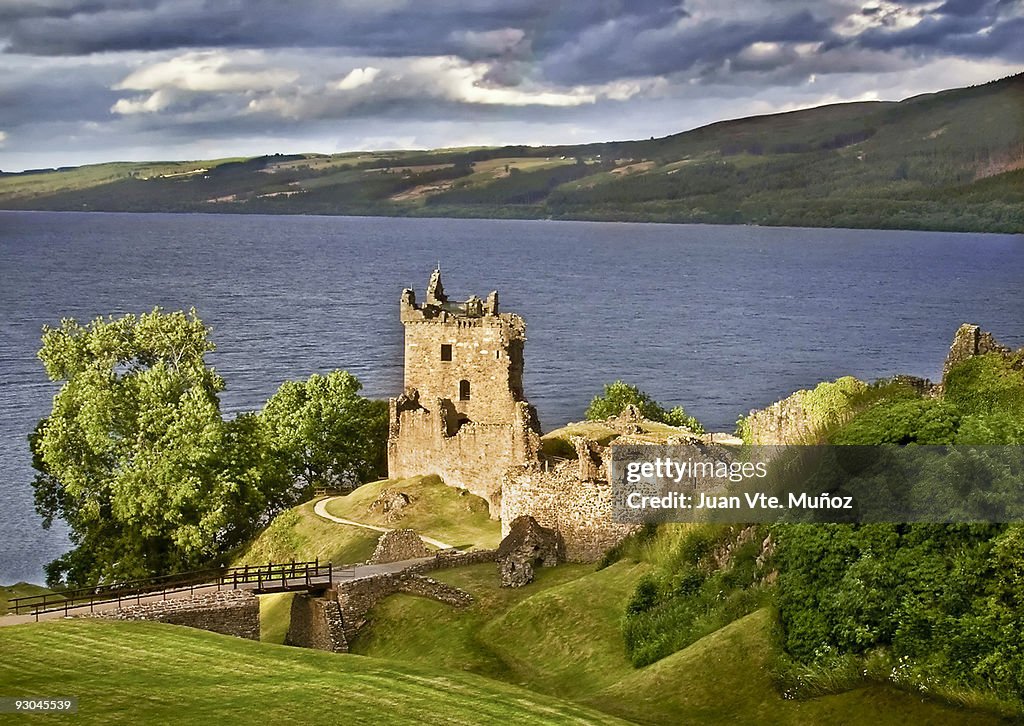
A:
[83, 590, 259, 640]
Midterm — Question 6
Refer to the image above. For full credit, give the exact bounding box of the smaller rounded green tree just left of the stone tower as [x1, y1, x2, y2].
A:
[259, 371, 388, 489]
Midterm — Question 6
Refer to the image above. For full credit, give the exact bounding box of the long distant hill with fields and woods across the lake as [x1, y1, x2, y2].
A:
[0, 74, 1024, 232]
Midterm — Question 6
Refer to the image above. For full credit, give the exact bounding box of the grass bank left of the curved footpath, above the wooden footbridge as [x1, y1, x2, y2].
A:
[231, 502, 380, 565]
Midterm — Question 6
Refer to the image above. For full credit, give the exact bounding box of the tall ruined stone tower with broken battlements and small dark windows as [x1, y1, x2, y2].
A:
[388, 269, 540, 517]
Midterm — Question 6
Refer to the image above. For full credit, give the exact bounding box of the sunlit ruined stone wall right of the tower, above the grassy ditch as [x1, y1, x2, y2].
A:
[502, 461, 636, 562]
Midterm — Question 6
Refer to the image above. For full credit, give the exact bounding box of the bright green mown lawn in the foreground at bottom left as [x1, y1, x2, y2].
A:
[0, 620, 622, 726]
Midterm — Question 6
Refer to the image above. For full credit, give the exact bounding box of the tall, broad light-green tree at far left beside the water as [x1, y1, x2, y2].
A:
[30, 308, 281, 585]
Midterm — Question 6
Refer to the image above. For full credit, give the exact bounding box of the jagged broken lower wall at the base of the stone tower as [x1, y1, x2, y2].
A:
[388, 401, 541, 511]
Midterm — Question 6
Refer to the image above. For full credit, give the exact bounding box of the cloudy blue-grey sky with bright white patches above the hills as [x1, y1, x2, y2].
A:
[0, 0, 1024, 171]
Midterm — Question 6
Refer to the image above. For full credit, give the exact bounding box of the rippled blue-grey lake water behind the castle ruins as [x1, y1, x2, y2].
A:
[0, 212, 1024, 583]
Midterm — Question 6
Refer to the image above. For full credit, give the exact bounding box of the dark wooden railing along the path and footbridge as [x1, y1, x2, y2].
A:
[7, 558, 354, 621]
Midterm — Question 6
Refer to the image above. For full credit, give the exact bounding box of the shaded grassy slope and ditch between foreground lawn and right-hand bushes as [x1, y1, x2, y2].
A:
[353, 562, 1001, 726]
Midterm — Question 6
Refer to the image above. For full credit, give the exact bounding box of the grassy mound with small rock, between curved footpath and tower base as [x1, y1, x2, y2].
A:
[317, 476, 502, 549]
